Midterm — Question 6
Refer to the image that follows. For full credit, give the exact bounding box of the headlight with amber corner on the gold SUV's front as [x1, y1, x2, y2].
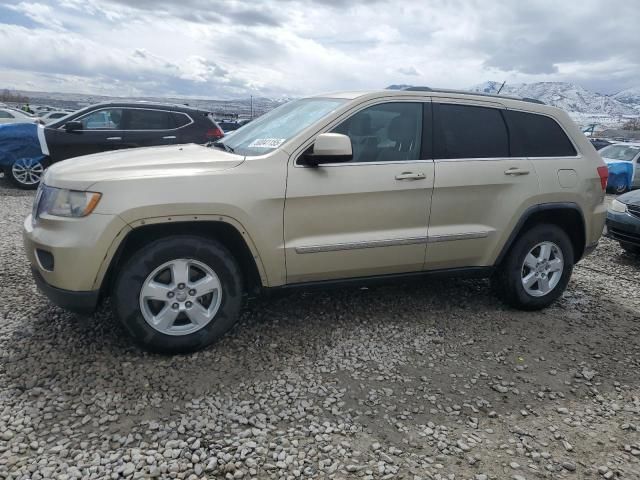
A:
[34, 185, 102, 218]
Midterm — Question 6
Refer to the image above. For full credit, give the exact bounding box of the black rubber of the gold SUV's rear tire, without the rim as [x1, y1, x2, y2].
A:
[491, 224, 575, 310]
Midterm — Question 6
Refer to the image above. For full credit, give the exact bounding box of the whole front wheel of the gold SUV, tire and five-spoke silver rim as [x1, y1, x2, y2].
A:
[113, 235, 243, 354]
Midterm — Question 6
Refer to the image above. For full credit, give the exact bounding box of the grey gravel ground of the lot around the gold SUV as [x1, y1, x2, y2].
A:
[0, 180, 640, 480]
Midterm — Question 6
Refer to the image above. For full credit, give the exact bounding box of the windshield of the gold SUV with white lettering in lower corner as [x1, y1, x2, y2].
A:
[218, 98, 346, 156]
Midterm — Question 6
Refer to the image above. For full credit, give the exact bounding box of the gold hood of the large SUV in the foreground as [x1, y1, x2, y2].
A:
[44, 144, 244, 190]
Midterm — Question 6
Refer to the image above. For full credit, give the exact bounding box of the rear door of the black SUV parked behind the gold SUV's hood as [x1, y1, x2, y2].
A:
[123, 108, 179, 148]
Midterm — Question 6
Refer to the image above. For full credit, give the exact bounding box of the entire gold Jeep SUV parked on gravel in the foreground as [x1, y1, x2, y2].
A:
[24, 88, 607, 352]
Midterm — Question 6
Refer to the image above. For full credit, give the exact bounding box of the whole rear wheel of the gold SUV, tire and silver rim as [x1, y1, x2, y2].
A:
[491, 224, 574, 310]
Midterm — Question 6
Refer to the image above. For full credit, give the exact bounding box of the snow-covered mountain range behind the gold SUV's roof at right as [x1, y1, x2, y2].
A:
[469, 81, 640, 116]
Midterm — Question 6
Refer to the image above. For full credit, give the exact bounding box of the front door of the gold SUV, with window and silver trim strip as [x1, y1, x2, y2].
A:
[284, 101, 434, 283]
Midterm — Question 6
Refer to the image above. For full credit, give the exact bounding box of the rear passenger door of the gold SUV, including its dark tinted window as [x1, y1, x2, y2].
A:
[425, 98, 538, 270]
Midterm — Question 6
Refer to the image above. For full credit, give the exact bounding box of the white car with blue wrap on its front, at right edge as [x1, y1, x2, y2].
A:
[600, 143, 640, 194]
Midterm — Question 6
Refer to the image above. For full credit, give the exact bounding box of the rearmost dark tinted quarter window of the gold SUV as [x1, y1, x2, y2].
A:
[504, 110, 576, 157]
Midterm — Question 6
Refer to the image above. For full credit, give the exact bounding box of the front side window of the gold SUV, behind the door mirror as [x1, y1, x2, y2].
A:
[333, 102, 422, 162]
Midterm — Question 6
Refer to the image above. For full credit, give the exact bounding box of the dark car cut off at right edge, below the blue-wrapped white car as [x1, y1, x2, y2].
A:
[606, 190, 640, 254]
